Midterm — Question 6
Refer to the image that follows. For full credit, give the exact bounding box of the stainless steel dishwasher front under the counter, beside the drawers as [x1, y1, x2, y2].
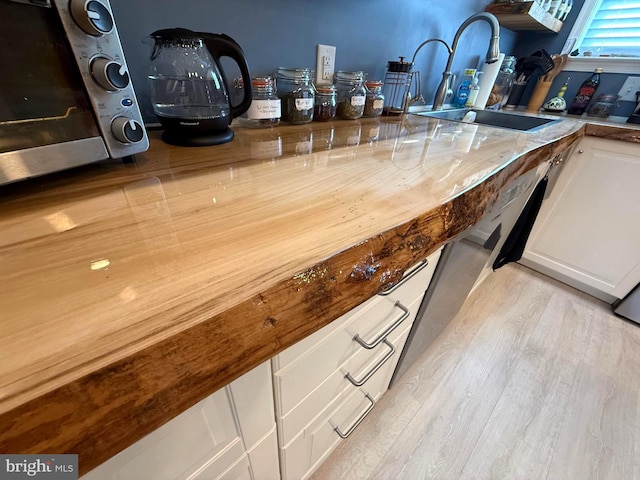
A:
[391, 159, 549, 385]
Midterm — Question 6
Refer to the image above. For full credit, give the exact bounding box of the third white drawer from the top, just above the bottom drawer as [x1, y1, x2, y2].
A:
[276, 301, 412, 446]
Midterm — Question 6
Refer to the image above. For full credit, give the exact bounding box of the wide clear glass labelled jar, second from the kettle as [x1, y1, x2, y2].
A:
[276, 67, 315, 124]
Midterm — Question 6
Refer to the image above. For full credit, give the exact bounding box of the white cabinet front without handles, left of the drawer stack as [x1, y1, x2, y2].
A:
[82, 362, 280, 480]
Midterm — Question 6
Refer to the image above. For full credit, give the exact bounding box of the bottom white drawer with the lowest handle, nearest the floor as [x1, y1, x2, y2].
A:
[281, 348, 393, 480]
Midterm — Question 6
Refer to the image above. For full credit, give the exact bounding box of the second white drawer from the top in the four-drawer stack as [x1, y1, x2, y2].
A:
[274, 297, 417, 415]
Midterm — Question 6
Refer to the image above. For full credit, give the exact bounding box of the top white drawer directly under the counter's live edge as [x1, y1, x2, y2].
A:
[273, 249, 442, 371]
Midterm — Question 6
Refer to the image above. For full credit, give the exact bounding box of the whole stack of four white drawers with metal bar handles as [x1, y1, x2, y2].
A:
[272, 251, 440, 480]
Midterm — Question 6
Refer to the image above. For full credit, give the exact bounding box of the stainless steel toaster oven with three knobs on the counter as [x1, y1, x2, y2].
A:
[0, 0, 149, 185]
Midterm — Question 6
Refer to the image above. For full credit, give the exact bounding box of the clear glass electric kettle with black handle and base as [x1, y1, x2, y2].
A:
[149, 28, 251, 146]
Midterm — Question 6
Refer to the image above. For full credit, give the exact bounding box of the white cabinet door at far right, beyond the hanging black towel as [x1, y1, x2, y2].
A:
[521, 137, 640, 303]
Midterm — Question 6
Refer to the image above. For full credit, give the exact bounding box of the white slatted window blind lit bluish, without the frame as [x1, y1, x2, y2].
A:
[580, 0, 640, 57]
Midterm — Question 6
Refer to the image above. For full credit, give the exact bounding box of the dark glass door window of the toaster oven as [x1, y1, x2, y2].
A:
[0, 0, 99, 153]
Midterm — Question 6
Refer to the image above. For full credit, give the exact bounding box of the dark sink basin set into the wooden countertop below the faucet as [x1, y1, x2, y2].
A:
[409, 108, 562, 132]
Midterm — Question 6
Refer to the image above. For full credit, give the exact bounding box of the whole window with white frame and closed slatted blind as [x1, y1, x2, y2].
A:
[563, 0, 640, 69]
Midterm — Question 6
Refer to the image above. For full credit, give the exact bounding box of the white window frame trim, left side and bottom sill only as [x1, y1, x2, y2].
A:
[562, 0, 640, 74]
